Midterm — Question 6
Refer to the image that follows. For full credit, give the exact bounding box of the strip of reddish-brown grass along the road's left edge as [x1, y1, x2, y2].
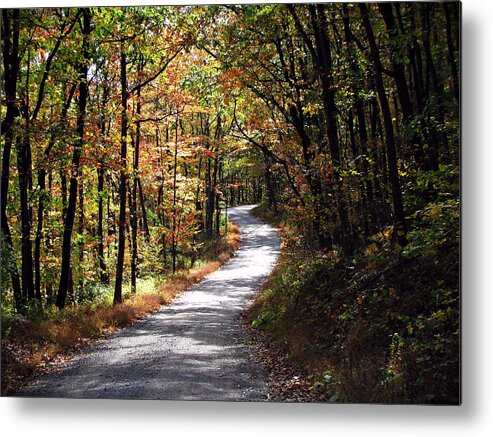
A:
[1, 223, 240, 396]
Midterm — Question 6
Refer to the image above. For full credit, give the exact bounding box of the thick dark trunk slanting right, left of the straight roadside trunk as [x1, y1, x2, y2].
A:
[56, 8, 91, 309]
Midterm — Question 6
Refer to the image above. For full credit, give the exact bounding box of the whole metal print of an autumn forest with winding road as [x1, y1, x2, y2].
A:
[1, 2, 461, 405]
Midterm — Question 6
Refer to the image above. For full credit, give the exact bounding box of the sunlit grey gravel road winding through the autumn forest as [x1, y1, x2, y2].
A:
[16, 205, 280, 401]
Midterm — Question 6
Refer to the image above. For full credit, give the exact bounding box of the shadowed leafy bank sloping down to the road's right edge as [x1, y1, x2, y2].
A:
[248, 206, 460, 404]
